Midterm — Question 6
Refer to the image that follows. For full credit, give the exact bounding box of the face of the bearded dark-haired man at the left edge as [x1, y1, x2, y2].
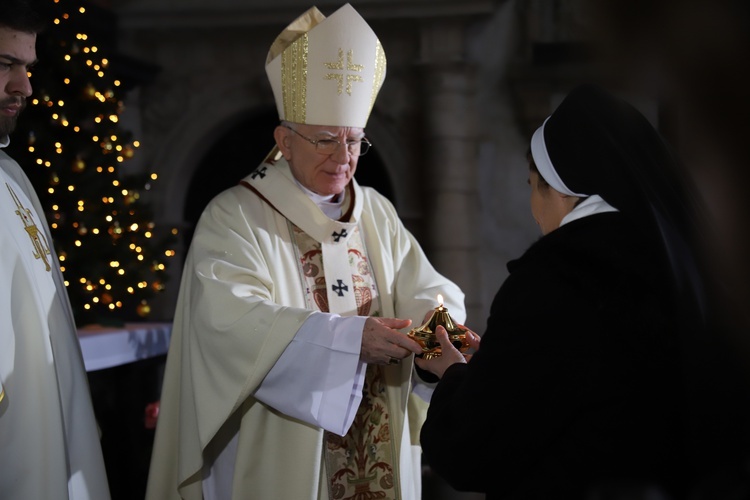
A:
[0, 27, 36, 138]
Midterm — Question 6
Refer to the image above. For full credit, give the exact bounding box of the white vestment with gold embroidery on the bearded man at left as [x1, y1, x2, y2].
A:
[0, 151, 109, 500]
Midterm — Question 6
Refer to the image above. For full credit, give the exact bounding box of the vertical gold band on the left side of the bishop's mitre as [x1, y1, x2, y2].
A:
[281, 33, 309, 123]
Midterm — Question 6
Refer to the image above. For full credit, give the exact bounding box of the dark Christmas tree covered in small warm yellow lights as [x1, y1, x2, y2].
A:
[8, 0, 176, 326]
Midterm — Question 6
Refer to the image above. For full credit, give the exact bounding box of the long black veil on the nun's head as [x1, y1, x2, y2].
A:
[543, 84, 709, 325]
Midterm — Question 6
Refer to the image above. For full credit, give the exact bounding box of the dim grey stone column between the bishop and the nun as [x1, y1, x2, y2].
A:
[421, 18, 486, 333]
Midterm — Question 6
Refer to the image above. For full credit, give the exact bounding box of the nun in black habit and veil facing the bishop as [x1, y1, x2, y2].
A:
[416, 84, 750, 500]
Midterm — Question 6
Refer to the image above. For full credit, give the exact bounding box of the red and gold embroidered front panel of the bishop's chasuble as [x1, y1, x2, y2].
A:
[290, 223, 400, 500]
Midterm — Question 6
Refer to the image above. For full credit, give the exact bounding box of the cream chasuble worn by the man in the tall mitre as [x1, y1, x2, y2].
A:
[146, 154, 465, 500]
